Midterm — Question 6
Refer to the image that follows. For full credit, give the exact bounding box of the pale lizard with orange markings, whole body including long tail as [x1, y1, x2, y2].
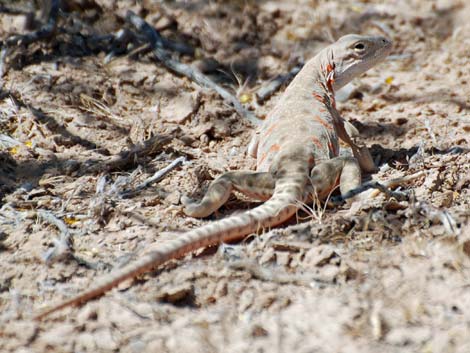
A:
[35, 34, 392, 320]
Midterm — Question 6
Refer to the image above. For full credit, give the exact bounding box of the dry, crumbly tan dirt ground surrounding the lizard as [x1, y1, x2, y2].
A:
[0, 0, 470, 353]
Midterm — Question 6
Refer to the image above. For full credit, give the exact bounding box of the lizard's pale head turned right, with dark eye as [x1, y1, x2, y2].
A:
[327, 34, 392, 90]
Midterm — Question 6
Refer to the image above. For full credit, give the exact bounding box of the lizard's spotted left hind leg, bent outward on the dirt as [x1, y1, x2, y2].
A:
[181, 171, 275, 218]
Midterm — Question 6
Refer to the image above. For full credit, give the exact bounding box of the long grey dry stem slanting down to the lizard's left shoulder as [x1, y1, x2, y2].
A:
[126, 11, 261, 125]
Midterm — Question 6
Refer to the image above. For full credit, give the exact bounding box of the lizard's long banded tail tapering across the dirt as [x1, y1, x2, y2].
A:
[34, 172, 308, 320]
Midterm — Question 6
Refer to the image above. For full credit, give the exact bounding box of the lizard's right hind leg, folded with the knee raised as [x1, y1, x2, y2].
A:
[310, 157, 361, 200]
